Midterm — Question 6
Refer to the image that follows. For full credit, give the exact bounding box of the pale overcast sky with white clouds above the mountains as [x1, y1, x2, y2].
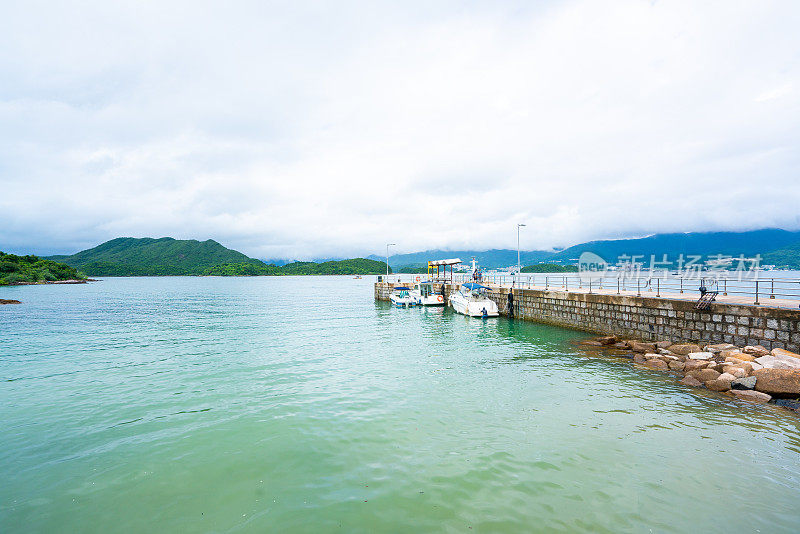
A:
[0, 0, 800, 258]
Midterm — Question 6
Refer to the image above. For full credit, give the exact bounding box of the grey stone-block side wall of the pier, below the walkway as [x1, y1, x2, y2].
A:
[375, 282, 800, 352]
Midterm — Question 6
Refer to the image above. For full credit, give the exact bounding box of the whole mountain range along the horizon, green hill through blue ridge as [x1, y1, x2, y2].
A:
[46, 229, 800, 276]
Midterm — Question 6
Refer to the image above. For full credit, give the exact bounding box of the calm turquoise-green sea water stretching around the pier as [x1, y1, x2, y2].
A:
[0, 277, 800, 533]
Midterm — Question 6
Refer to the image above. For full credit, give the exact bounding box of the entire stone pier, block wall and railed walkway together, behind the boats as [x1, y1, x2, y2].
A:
[375, 275, 800, 352]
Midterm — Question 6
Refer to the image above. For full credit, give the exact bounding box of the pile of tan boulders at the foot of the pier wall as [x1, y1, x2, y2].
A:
[583, 336, 800, 412]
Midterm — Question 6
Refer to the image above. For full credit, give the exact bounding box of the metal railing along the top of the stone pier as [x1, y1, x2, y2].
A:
[380, 273, 800, 305]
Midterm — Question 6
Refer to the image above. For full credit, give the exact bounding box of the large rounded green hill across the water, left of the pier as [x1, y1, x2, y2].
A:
[49, 237, 268, 276]
